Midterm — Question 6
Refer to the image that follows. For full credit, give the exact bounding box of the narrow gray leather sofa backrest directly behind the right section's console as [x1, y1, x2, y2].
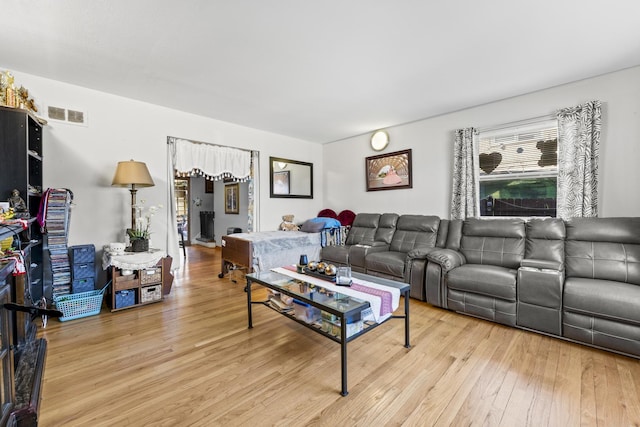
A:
[524, 218, 566, 265]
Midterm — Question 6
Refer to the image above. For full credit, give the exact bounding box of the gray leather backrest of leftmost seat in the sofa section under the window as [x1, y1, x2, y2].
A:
[460, 218, 525, 268]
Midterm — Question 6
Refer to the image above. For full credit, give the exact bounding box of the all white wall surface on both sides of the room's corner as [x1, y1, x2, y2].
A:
[6, 66, 640, 260]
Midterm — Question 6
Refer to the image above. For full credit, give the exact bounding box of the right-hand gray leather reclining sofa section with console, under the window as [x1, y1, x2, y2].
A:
[426, 218, 640, 358]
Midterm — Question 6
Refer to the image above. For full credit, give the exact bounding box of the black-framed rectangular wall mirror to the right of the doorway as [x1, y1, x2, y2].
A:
[269, 157, 313, 199]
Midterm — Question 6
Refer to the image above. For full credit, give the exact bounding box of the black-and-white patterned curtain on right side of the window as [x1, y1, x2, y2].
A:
[557, 101, 602, 219]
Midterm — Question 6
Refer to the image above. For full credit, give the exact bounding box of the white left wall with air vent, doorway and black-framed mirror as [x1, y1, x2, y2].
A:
[0, 65, 323, 252]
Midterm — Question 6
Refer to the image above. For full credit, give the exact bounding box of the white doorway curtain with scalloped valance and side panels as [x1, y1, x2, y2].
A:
[167, 137, 257, 265]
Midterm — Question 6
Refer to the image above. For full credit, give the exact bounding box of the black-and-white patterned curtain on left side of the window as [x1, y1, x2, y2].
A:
[451, 128, 478, 219]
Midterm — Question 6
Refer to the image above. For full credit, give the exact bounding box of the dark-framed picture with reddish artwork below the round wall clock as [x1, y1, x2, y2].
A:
[365, 149, 413, 191]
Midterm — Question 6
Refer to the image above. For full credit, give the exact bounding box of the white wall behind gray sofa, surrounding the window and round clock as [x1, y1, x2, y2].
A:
[323, 67, 640, 218]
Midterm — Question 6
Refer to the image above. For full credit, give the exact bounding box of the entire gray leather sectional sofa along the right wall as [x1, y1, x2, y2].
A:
[322, 214, 640, 358]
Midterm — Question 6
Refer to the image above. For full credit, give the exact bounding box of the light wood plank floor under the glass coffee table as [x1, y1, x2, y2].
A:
[40, 247, 640, 427]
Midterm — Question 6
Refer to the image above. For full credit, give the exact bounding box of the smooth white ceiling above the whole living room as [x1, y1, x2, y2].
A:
[0, 0, 640, 143]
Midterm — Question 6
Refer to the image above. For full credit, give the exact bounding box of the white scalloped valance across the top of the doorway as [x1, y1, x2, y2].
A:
[174, 138, 251, 180]
